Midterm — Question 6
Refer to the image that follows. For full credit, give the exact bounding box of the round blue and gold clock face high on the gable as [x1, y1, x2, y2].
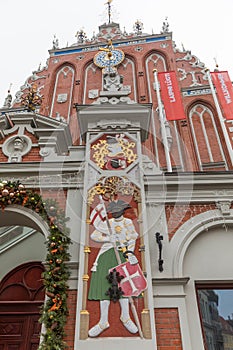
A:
[94, 49, 125, 68]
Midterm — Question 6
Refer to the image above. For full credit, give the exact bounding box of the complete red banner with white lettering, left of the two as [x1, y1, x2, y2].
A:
[158, 72, 186, 120]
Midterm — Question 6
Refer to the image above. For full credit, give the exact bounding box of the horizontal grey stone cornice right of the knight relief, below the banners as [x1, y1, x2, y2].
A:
[144, 171, 233, 205]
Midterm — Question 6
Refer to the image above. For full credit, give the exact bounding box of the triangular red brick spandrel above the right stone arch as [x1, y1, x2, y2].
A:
[165, 204, 216, 240]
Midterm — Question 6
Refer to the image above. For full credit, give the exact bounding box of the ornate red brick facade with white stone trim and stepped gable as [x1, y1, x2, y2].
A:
[0, 8, 233, 350]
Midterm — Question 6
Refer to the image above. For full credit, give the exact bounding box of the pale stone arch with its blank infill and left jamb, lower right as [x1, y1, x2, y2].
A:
[169, 209, 233, 350]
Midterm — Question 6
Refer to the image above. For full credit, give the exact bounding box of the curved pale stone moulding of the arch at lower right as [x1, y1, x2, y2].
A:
[170, 209, 233, 279]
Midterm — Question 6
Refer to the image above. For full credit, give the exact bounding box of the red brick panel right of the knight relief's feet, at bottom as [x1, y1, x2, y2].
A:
[155, 308, 183, 350]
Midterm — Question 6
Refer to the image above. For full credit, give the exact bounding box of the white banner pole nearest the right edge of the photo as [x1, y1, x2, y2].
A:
[205, 68, 233, 165]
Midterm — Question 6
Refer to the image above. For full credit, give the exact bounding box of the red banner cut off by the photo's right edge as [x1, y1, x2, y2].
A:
[211, 72, 233, 119]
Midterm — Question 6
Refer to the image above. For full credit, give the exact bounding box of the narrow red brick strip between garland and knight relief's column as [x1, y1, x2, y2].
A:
[65, 290, 77, 350]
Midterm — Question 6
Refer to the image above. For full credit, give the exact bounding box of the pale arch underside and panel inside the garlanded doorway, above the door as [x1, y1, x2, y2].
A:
[0, 205, 49, 279]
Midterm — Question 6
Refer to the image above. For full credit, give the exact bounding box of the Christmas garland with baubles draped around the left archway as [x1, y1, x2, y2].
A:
[0, 180, 71, 350]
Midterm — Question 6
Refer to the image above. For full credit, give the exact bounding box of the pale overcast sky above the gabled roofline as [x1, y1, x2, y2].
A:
[0, 0, 233, 106]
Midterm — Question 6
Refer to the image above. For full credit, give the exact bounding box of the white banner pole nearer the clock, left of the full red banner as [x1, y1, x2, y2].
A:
[153, 69, 172, 173]
